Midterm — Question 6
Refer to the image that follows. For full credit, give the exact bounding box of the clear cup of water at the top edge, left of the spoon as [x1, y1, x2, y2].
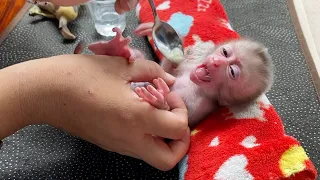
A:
[87, 0, 126, 36]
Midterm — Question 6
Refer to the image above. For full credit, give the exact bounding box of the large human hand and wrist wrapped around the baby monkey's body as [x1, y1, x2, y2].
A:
[14, 55, 190, 170]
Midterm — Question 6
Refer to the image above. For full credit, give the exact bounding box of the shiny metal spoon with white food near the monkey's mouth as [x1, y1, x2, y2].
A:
[149, 0, 184, 64]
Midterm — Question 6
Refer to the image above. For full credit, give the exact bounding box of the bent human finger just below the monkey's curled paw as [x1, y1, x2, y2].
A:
[142, 92, 188, 139]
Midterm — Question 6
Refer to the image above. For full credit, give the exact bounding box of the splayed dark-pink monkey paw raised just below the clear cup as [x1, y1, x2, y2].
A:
[88, 27, 144, 63]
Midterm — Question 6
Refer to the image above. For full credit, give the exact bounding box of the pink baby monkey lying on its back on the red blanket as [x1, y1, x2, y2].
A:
[82, 23, 273, 128]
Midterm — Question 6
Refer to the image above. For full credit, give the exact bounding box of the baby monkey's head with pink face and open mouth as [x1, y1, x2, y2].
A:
[190, 39, 273, 106]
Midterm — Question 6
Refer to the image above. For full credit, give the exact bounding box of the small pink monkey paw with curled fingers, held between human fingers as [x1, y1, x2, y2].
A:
[135, 78, 170, 110]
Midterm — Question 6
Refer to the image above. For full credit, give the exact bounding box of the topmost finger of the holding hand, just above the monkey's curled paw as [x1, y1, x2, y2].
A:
[127, 59, 175, 86]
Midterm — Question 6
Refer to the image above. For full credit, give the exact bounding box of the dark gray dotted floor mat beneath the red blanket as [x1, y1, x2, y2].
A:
[0, 0, 320, 179]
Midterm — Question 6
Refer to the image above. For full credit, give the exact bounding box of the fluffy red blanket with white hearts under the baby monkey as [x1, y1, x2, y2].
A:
[136, 0, 317, 180]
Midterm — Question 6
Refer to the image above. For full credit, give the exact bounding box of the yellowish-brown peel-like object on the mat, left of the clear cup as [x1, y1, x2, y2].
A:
[28, 0, 79, 40]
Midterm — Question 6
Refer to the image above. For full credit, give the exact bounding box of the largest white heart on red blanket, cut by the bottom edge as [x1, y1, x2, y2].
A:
[213, 154, 253, 180]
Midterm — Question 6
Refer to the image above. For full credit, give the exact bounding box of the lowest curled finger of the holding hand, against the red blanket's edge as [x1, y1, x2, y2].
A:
[140, 129, 190, 171]
